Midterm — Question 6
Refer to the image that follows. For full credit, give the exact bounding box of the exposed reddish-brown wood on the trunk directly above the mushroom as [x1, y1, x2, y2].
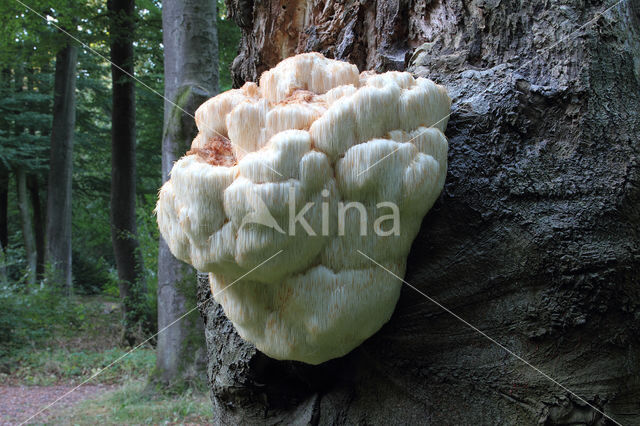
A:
[227, 0, 412, 87]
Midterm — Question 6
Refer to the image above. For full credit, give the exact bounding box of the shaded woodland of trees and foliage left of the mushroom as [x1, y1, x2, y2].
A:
[0, 0, 240, 400]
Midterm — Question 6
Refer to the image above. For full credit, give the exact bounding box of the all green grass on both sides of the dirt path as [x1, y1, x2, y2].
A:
[0, 294, 213, 426]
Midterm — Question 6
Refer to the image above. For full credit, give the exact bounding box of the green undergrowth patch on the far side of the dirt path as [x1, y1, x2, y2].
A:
[0, 293, 155, 386]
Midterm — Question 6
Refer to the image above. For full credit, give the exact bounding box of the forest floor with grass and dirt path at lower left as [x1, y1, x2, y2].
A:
[0, 297, 212, 426]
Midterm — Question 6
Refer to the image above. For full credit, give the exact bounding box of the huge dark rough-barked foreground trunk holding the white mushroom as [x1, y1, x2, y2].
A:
[199, 0, 640, 424]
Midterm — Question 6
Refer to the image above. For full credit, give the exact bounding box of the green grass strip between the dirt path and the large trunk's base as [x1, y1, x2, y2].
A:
[47, 380, 213, 425]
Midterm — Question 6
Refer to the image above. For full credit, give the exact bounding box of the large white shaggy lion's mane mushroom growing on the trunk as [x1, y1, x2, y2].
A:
[157, 53, 451, 364]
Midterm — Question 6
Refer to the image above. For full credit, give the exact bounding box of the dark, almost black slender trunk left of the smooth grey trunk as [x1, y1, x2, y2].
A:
[107, 0, 146, 344]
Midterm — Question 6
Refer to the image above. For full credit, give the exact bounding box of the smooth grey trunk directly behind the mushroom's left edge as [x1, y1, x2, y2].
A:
[157, 0, 218, 383]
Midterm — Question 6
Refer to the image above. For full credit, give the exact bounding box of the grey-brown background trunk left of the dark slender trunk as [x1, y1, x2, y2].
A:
[46, 44, 78, 292]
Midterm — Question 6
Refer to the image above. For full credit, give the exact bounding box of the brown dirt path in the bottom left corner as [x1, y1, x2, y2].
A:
[0, 385, 116, 425]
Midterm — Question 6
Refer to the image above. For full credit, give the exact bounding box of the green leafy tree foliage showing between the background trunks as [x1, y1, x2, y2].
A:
[0, 0, 240, 300]
